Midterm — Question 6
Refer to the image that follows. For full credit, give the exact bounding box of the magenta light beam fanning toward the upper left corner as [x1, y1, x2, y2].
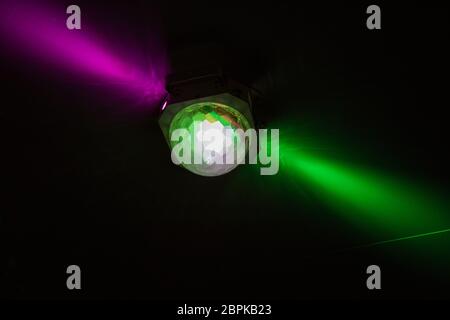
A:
[0, 1, 165, 108]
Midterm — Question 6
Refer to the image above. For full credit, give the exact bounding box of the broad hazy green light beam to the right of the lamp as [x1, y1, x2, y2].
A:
[280, 136, 450, 237]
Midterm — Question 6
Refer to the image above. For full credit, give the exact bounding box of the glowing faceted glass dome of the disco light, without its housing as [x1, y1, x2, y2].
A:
[169, 102, 251, 176]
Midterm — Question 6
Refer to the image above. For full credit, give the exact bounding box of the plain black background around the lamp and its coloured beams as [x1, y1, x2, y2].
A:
[0, 1, 450, 299]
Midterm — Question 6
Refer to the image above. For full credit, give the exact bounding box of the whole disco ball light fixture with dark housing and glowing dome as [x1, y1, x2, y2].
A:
[159, 75, 255, 177]
